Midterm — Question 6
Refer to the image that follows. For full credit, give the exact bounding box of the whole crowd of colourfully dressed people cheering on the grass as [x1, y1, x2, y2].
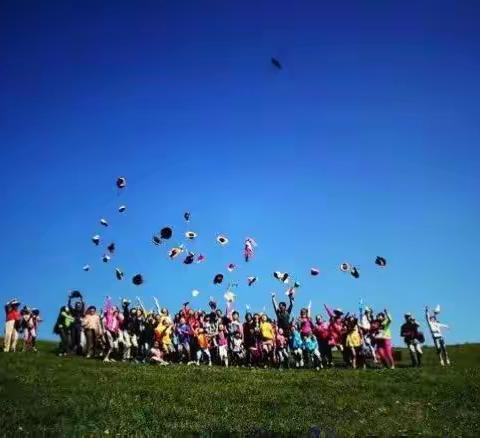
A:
[4, 291, 450, 370]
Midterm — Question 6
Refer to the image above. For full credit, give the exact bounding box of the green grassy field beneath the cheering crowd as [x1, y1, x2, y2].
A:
[0, 343, 480, 436]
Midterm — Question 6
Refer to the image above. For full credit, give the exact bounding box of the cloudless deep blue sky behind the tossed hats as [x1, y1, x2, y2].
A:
[0, 0, 480, 342]
